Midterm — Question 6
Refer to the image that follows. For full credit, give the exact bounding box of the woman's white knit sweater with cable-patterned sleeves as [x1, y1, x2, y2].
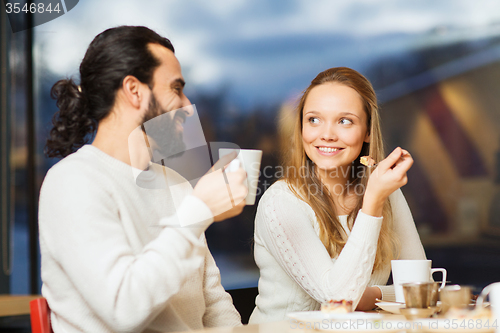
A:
[250, 181, 426, 323]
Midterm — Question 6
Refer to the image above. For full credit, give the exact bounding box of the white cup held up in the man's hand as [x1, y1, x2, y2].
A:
[219, 148, 262, 205]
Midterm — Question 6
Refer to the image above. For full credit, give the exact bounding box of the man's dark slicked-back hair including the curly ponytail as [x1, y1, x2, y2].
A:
[45, 26, 174, 157]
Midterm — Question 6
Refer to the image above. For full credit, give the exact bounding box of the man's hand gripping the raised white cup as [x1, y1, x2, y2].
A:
[193, 152, 248, 221]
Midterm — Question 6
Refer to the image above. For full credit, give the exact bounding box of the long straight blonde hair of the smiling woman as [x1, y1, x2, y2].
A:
[284, 67, 399, 270]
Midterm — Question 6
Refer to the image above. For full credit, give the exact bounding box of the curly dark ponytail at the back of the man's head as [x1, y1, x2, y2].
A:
[45, 79, 97, 157]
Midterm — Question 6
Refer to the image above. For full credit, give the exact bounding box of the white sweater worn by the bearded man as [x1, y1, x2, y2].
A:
[39, 145, 241, 333]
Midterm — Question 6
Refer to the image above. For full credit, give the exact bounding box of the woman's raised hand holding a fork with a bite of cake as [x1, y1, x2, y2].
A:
[361, 147, 413, 216]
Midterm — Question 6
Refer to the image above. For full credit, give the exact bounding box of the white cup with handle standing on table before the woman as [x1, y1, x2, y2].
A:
[391, 260, 446, 303]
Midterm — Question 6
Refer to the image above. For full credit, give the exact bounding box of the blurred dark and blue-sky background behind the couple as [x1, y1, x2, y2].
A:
[0, 0, 500, 326]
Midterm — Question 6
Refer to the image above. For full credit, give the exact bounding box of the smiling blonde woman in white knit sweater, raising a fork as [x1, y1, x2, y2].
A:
[250, 67, 425, 323]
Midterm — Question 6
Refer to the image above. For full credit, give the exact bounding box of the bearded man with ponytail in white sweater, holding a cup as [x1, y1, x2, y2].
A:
[39, 26, 247, 333]
